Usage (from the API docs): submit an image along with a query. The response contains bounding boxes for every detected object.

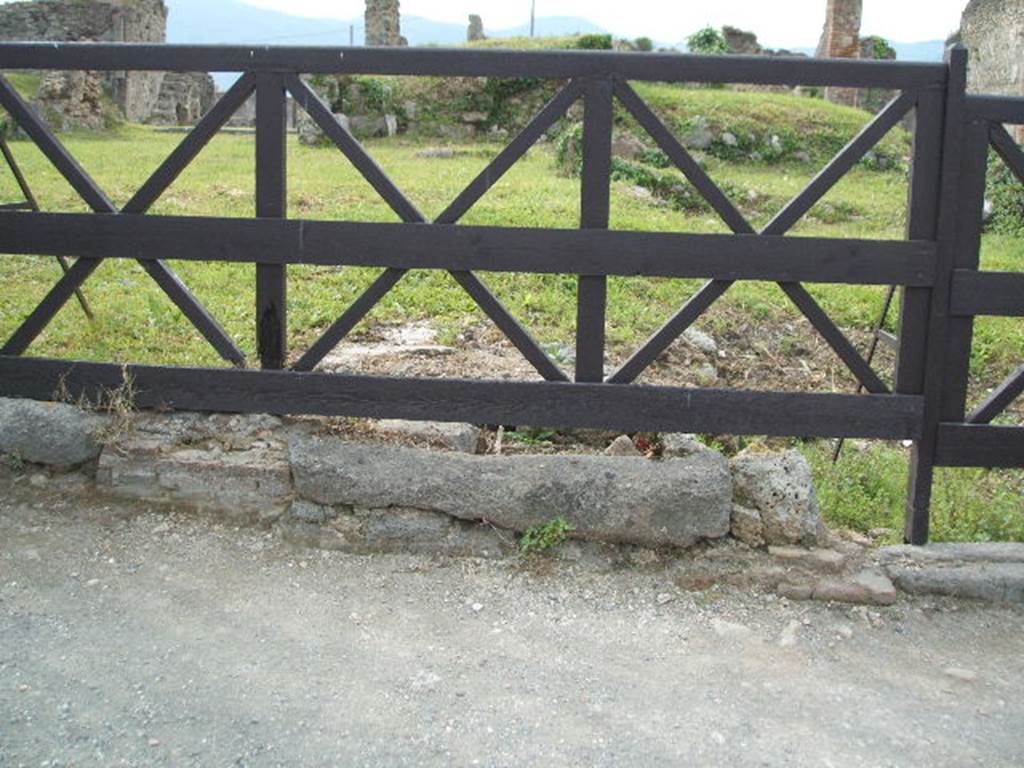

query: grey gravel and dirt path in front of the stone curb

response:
[0,480,1024,768]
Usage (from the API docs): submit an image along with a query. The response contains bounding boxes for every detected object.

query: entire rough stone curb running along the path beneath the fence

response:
[0,398,1024,605]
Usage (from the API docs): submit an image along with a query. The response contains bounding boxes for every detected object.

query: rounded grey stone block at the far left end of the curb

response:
[0,397,109,467]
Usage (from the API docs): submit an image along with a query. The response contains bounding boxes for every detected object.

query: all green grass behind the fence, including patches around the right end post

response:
[0,121,1024,539]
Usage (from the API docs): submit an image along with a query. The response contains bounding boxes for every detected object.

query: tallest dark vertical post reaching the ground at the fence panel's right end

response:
[898,46,967,545]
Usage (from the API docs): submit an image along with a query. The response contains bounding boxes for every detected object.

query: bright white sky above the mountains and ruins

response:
[239,0,967,47]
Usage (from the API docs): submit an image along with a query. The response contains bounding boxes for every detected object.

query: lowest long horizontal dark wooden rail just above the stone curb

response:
[0,356,923,439]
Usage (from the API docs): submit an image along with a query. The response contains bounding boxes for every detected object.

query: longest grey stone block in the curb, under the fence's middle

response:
[291,436,732,547]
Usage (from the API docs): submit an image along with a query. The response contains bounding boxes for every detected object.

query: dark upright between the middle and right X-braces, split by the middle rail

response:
[575,78,612,382]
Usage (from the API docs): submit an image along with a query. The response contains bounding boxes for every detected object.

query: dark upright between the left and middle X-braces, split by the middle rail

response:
[256,74,288,369]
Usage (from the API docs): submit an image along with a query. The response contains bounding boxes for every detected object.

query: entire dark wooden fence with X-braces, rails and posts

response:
[0,43,1024,543]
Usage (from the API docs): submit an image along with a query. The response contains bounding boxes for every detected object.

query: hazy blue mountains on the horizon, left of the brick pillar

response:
[167,0,605,45]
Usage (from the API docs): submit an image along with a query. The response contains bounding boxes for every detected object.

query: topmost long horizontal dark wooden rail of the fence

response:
[0,43,947,88]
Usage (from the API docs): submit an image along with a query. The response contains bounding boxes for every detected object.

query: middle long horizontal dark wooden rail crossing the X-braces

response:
[0,212,935,286]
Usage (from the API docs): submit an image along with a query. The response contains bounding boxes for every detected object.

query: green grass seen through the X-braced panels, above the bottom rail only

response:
[0,127,925,364]
